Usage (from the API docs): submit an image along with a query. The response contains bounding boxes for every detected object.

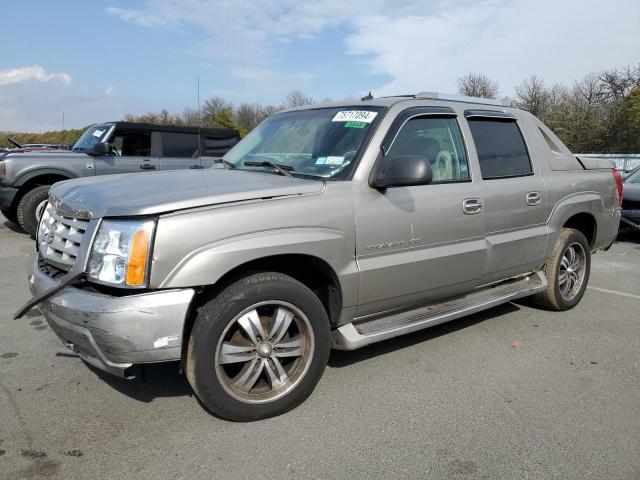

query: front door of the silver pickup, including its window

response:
[355,109,486,316]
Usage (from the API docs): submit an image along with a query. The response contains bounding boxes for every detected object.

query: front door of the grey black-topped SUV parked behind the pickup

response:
[96,129,158,175]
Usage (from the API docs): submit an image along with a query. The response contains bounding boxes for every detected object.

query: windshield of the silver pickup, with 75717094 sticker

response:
[224,107,382,178]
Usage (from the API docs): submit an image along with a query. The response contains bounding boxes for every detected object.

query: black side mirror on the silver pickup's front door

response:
[371,155,433,188]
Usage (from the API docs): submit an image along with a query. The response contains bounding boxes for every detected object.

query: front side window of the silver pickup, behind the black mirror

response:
[387,117,470,183]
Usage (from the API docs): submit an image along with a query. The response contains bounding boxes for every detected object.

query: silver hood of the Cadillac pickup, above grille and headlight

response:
[49,168,325,219]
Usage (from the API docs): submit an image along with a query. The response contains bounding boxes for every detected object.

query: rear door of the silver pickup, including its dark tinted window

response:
[465,110,547,281]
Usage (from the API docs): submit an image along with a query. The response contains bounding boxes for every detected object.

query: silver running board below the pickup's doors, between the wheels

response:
[332,272,547,350]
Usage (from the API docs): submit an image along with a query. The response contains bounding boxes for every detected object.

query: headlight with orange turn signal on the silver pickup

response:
[87,220,155,288]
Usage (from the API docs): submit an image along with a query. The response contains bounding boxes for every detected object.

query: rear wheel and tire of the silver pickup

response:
[532,228,591,311]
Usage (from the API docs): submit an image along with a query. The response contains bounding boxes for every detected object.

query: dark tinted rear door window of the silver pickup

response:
[469,118,532,180]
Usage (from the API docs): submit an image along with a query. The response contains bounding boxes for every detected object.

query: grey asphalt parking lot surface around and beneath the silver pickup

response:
[0,217,640,479]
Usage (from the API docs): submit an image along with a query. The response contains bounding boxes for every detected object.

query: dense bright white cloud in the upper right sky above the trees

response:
[347,0,640,95]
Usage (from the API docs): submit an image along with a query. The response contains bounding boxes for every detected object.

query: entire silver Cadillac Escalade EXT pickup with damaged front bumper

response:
[16,93,622,420]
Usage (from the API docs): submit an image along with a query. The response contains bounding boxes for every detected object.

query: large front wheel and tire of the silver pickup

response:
[185,272,331,421]
